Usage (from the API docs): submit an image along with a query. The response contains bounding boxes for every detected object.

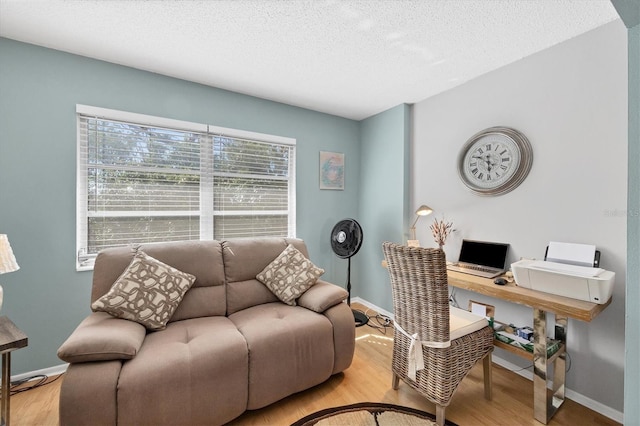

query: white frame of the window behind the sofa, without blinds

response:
[76,104,296,271]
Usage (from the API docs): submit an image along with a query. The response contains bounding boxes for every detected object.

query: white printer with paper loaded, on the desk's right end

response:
[511,242,616,304]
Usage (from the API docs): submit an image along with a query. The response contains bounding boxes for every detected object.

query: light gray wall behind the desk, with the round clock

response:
[411,21,624,412]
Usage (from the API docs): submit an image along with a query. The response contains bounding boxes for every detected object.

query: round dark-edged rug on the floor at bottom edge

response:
[291,402,457,426]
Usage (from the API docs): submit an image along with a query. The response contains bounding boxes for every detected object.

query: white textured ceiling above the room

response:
[0,0,619,120]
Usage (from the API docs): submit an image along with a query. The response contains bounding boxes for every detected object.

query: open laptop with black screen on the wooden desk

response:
[447,240,509,278]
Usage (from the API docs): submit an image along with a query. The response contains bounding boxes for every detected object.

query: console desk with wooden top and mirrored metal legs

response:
[447,271,611,424]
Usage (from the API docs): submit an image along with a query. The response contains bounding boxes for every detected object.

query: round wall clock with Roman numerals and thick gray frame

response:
[458,127,533,195]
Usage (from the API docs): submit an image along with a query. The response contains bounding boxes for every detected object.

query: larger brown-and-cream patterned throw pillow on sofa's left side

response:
[91,250,196,330]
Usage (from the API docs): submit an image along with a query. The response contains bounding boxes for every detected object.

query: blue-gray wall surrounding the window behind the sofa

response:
[0,38,360,374]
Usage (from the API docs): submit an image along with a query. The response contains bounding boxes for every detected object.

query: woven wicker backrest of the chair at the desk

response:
[382,242,449,342]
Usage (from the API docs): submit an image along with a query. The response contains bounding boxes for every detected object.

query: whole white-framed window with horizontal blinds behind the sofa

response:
[77,105,295,269]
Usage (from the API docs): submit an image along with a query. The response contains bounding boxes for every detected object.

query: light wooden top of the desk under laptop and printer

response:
[447,271,611,322]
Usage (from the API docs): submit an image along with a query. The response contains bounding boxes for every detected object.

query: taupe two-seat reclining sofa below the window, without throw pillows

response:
[58,238,355,426]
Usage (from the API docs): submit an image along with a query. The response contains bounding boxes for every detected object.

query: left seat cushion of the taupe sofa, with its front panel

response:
[117,316,249,425]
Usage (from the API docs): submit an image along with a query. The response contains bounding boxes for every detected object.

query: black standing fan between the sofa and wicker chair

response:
[331,219,369,327]
